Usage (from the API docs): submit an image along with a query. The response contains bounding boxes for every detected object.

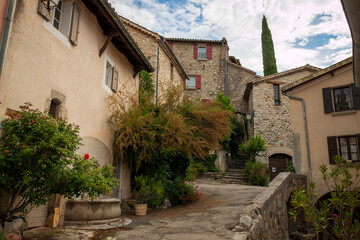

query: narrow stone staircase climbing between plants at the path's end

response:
[220,154,250,185]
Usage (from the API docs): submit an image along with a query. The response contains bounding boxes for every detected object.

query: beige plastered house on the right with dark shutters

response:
[283,57,360,198]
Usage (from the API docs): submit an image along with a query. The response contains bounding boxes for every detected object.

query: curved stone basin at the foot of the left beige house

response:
[65,198,121,225]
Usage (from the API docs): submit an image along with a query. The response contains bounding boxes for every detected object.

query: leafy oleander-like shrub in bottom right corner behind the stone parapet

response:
[289,156,360,240]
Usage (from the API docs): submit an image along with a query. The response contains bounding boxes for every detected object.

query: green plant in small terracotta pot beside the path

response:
[133,175,153,216]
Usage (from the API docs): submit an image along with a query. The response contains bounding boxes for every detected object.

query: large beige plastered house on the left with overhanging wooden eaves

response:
[0,0,153,227]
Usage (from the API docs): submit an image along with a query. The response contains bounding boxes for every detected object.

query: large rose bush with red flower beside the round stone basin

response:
[0,103,117,218]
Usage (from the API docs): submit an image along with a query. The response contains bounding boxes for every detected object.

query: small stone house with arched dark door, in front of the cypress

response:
[248,65,319,179]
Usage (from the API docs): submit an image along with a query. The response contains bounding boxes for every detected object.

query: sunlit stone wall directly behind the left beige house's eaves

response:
[123,20,185,100]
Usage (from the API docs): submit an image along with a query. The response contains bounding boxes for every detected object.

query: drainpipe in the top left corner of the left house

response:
[0,0,17,79]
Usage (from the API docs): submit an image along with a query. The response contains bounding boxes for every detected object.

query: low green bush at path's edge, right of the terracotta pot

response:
[167,178,201,206]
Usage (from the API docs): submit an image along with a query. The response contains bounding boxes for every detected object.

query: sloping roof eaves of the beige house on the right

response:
[281,57,352,92]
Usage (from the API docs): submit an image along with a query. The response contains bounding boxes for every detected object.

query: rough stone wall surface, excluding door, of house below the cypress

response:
[252,71,311,164]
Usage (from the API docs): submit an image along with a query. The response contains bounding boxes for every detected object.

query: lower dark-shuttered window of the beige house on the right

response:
[327,134,360,164]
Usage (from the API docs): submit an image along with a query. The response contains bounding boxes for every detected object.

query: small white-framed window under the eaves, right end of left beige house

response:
[103,54,119,93]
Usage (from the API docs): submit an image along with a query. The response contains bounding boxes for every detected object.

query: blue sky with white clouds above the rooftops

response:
[108,0,352,76]
